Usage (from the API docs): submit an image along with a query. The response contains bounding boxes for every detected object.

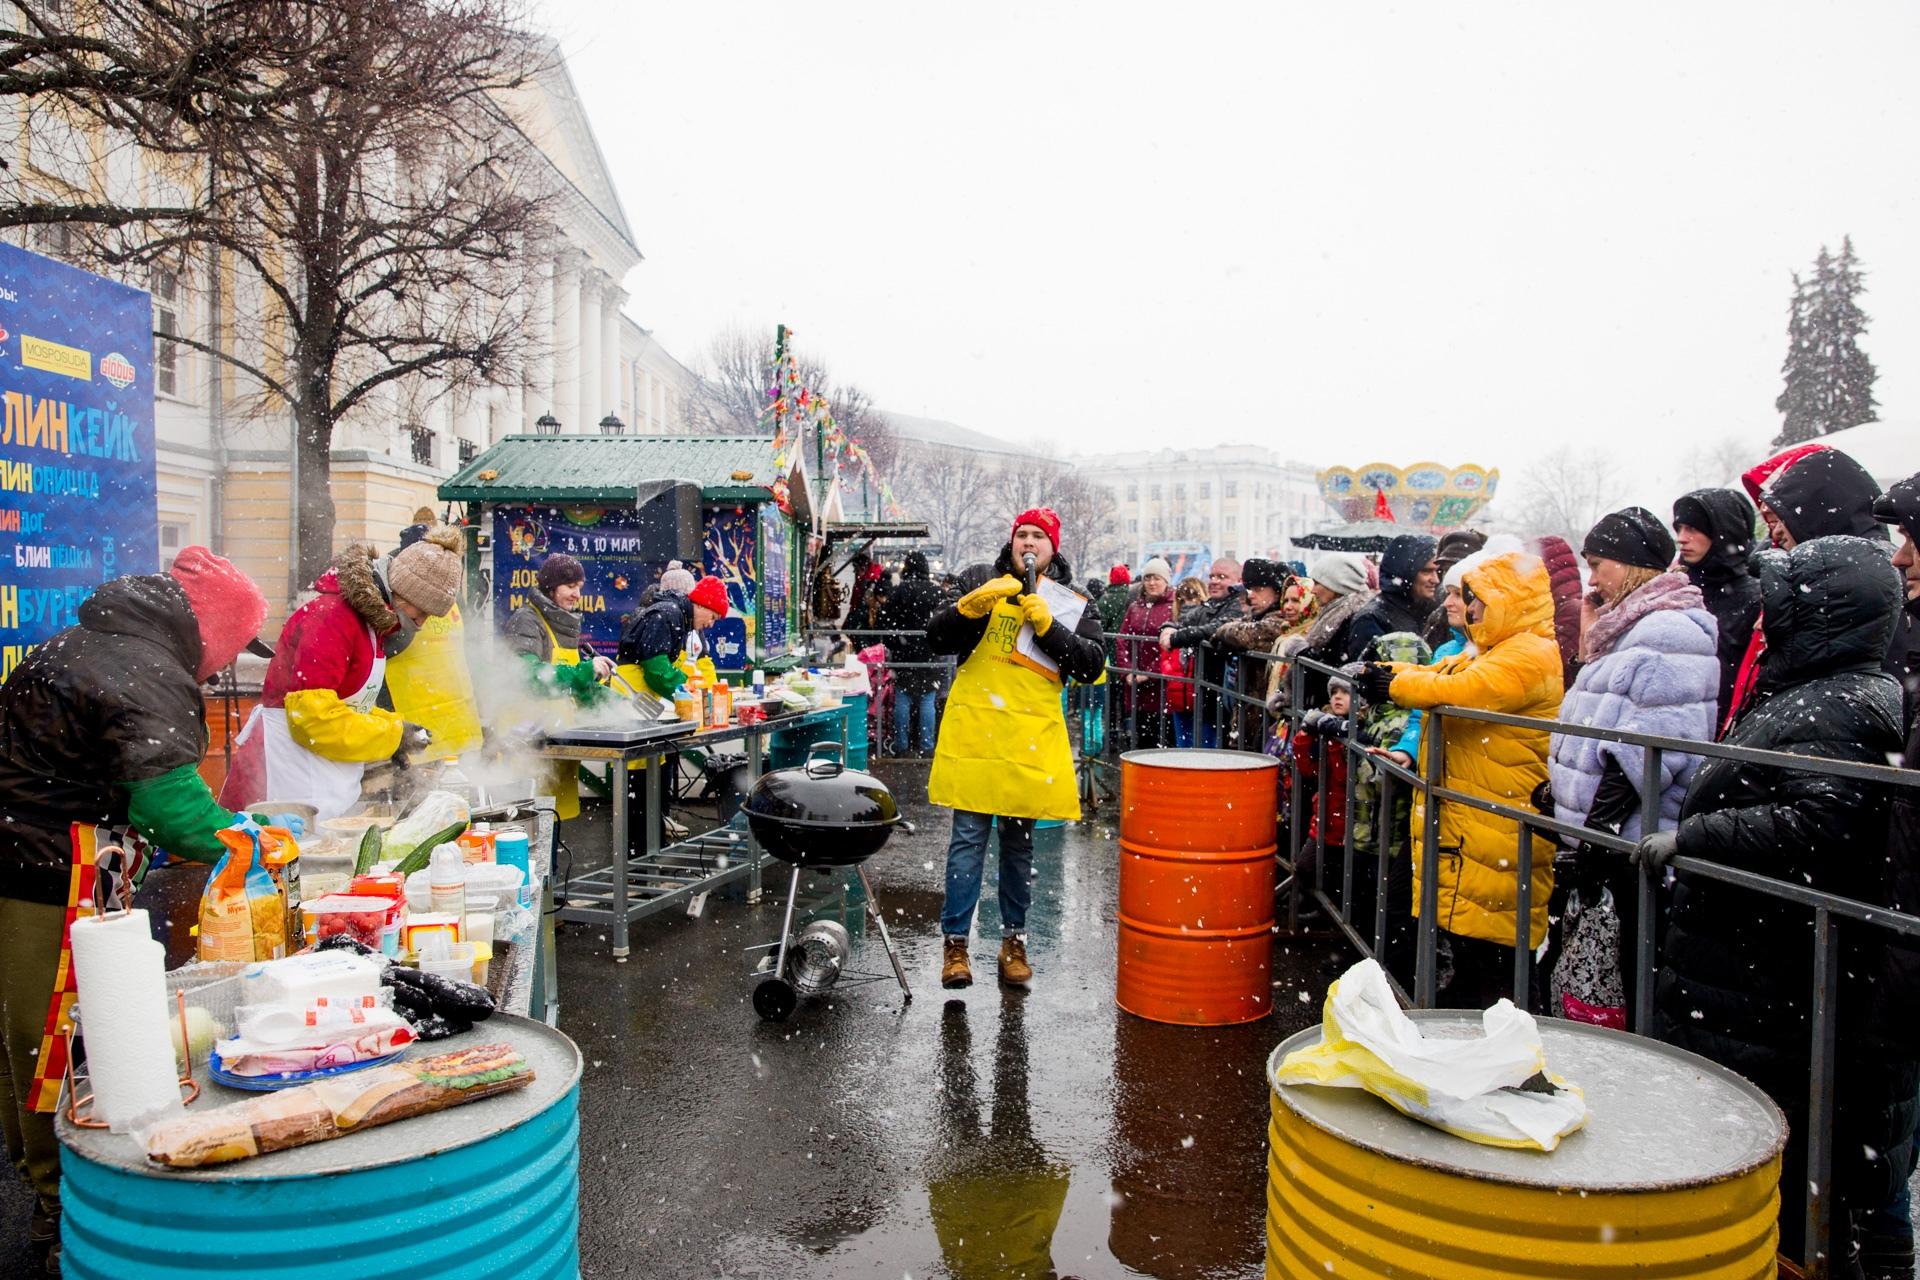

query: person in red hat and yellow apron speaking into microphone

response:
[927,507,1106,986]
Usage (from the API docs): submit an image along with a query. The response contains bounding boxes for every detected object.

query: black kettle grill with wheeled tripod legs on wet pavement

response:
[741,743,914,1023]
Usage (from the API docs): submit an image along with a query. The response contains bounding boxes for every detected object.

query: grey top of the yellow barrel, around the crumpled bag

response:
[1267,1009,1788,1192]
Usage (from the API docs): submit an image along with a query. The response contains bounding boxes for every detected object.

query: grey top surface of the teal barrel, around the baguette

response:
[58,1013,580,1182]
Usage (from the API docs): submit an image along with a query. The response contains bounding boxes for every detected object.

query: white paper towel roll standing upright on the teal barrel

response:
[73,912,180,1134]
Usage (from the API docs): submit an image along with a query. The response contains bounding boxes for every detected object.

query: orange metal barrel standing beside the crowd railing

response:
[1116,750,1281,1027]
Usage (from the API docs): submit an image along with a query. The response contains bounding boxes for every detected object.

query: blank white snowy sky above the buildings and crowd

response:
[536,0,1920,495]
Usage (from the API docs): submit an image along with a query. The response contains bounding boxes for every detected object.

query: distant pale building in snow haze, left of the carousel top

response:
[1073,445,1331,564]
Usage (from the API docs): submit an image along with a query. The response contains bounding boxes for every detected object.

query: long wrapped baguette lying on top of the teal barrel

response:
[146,1044,534,1169]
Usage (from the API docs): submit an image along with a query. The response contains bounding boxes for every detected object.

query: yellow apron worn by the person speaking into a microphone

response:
[927,601,1079,821]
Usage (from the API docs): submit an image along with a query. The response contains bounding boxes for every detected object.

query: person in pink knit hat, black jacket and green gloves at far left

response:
[0,547,267,1255]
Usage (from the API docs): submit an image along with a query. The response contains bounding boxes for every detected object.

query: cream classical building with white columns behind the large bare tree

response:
[0,46,697,621]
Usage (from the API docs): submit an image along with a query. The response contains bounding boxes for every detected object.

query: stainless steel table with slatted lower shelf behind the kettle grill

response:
[538,706,847,960]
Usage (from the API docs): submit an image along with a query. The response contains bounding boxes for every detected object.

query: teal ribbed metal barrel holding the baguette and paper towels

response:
[60,1015,580,1280]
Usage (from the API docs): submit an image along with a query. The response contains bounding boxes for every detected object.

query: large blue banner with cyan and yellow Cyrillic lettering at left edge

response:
[0,244,159,677]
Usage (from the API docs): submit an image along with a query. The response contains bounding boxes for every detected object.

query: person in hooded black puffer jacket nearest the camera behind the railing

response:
[1638,535,1920,1274]
